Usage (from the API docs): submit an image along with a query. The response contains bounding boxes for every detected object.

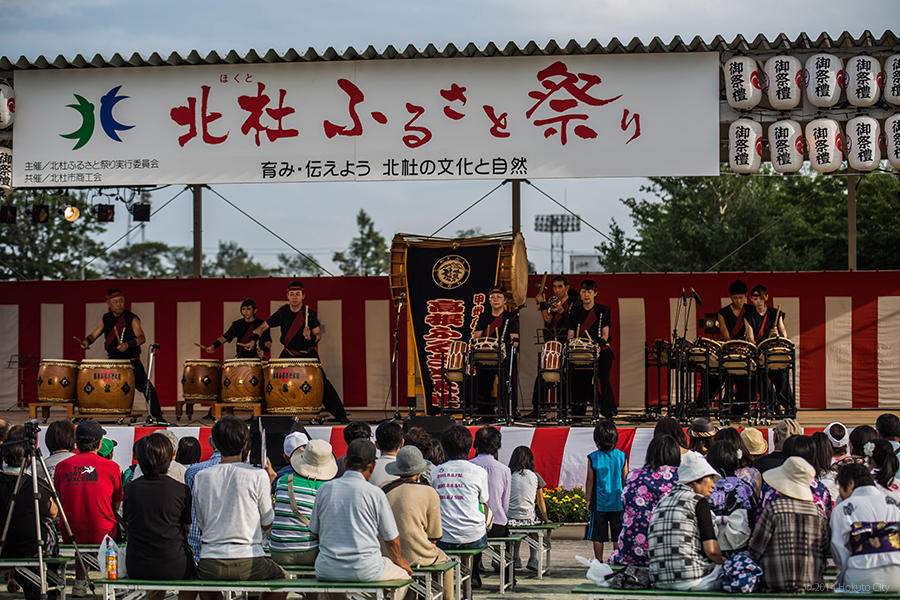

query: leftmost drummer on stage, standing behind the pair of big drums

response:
[81,288,165,425]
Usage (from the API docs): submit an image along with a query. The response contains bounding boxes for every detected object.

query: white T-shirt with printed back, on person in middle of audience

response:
[431,460,489,544]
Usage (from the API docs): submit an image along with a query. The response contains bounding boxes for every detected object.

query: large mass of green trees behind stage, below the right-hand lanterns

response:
[597,173,900,271]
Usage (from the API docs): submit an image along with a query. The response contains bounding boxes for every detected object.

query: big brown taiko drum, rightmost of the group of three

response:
[265,358,325,414]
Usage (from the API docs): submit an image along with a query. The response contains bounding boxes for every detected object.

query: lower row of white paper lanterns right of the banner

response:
[728,114,900,174]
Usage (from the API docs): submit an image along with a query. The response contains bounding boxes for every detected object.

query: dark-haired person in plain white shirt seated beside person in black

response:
[193,416,287,599]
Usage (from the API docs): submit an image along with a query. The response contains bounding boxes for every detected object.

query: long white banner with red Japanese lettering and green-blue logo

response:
[13,53,719,187]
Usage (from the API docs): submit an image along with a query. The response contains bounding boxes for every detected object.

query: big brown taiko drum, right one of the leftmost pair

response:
[78,359,134,415]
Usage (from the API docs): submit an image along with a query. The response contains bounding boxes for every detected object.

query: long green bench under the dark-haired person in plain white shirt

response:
[95,579,413,600]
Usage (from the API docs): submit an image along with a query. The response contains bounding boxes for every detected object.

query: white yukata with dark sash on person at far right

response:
[831,485,900,581]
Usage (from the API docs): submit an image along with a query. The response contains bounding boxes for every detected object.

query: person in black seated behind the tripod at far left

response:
[0,425,59,600]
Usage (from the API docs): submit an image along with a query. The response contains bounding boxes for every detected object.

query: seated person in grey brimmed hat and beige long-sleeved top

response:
[381,446,454,600]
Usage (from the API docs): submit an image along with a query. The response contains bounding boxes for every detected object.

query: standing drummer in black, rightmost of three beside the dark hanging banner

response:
[568,279,618,419]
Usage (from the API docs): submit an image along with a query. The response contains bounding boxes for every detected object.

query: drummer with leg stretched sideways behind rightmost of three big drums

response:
[251,281,349,423]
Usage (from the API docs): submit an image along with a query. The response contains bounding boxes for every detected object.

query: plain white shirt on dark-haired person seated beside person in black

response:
[193,463,275,558]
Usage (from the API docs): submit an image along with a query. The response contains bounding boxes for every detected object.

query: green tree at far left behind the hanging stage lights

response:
[0,190,106,279]
